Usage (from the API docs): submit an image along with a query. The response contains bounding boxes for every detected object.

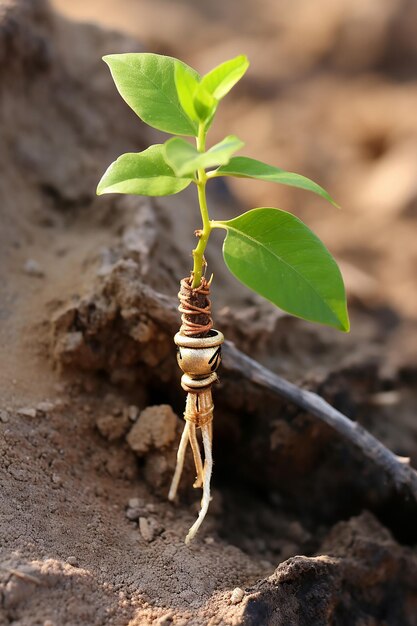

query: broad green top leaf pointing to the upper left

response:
[103,53,200,136]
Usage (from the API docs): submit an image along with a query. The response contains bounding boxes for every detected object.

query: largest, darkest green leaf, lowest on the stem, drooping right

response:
[212,208,349,332]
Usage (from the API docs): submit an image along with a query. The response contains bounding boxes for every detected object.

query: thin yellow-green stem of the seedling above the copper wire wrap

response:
[191,124,211,289]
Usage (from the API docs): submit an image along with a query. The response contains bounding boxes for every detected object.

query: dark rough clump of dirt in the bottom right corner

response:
[244,513,417,626]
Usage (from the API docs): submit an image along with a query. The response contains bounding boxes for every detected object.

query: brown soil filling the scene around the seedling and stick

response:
[0,0,417,626]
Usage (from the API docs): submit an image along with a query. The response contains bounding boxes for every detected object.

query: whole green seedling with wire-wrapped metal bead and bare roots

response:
[97,53,349,542]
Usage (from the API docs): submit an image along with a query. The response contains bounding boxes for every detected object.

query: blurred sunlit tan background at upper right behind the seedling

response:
[52,0,417,326]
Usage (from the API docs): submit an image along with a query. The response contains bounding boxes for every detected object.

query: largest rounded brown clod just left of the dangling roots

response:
[127,404,178,457]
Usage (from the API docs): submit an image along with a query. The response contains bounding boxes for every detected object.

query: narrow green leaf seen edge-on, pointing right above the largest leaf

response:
[212,157,339,208]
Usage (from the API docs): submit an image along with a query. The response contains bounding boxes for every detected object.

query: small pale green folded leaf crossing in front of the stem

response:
[164,135,244,176]
